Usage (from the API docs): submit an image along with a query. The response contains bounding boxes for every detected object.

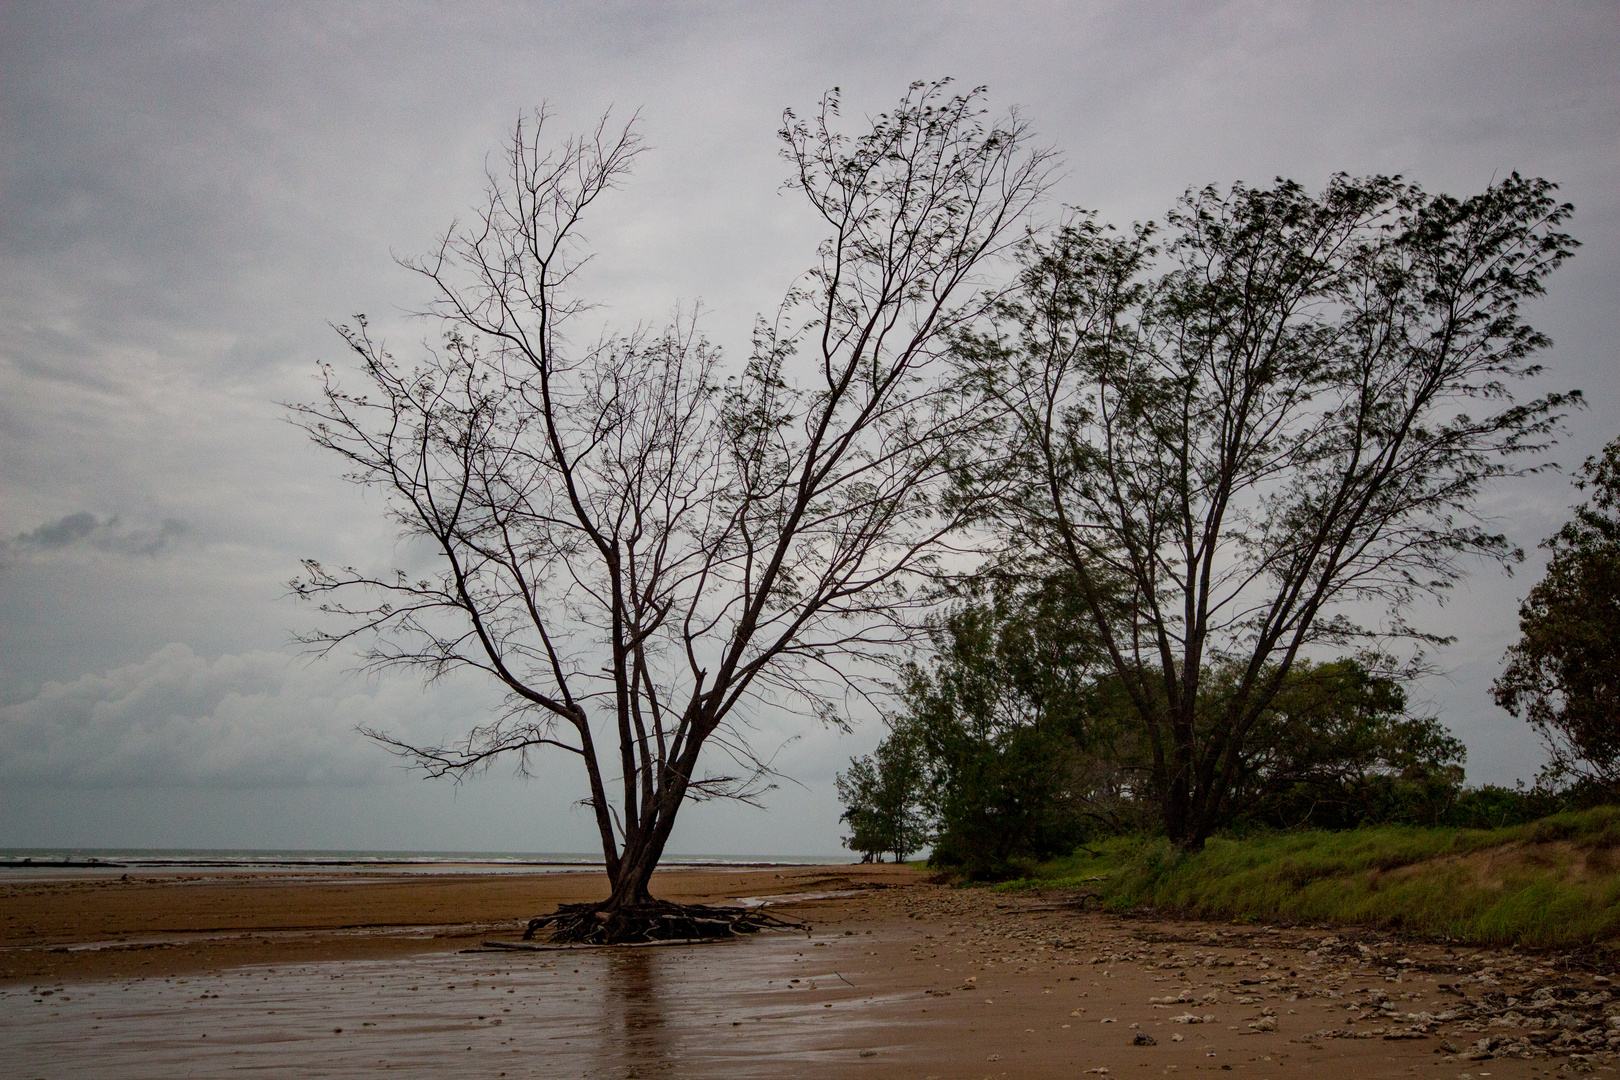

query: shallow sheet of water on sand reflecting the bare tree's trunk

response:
[0,934,926,1080]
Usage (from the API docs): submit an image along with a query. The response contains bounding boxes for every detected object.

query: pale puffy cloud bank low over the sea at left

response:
[0,643,476,787]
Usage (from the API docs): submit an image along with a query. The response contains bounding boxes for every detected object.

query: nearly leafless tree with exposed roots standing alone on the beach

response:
[293,83,1050,939]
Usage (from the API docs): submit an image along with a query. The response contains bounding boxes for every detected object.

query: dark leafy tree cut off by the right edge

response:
[1494,439,1620,792]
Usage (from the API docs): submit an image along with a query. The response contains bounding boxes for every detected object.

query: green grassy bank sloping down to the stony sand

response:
[1009,806,1620,947]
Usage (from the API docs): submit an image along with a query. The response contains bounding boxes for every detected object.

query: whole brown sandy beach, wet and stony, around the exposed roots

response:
[0,866,1620,1080]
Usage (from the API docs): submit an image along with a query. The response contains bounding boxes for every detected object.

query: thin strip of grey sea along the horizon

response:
[0,847,855,876]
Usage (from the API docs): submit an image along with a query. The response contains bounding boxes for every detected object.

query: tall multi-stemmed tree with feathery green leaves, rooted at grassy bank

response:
[962,175,1580,848]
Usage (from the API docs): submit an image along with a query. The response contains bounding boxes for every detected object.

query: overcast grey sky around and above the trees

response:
[0,0,1620,853]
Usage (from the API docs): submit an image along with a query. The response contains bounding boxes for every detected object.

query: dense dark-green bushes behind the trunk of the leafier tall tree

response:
[839,572,1483,879]
